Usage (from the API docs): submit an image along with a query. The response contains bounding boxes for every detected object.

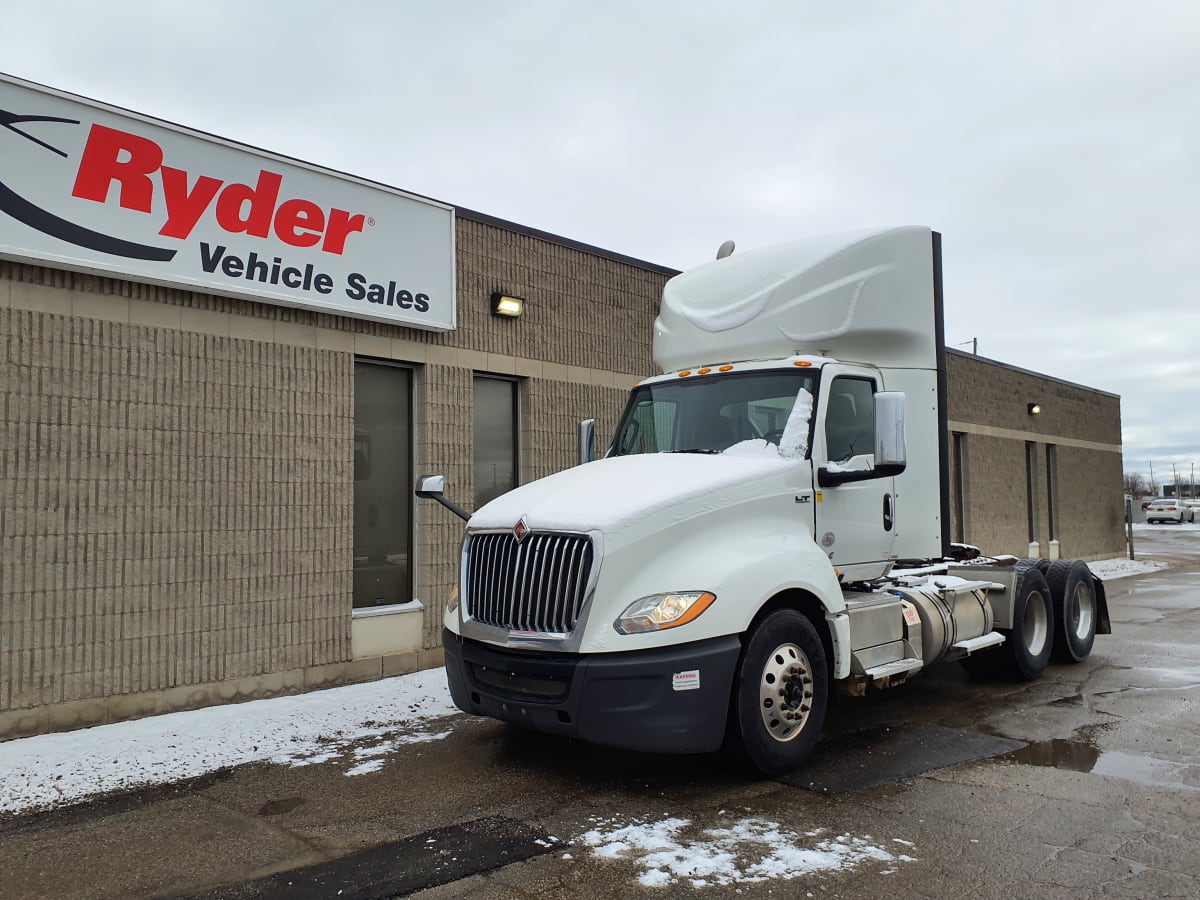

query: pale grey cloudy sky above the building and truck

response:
[0,0,1200,480]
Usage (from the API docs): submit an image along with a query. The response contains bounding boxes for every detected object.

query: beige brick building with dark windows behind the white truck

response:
[0,81,1123,739]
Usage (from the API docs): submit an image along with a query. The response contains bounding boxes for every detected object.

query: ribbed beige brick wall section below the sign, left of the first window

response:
[0,308,353,709]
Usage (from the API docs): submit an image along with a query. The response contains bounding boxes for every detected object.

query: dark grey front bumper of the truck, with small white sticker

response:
[442,630,742,754]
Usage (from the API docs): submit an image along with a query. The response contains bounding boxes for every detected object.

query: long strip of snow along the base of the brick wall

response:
[0,668,458,815]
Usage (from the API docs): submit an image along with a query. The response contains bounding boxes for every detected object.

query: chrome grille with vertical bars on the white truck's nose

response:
[463,533,592,634]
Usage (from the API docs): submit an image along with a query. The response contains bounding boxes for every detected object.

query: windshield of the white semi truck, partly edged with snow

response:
[608,368,817,456]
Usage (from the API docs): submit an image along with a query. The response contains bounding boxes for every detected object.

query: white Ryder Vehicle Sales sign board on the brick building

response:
[0,74,456,331]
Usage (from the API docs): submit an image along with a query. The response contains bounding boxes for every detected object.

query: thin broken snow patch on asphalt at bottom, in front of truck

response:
[578,817,914,888]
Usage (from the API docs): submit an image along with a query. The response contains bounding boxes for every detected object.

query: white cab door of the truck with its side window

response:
[812,373,895,581]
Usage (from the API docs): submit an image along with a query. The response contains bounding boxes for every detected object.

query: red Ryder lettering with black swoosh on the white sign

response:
[0,109,364,262]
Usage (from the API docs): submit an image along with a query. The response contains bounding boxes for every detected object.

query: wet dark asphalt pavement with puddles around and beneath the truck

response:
[0,526,1200,900]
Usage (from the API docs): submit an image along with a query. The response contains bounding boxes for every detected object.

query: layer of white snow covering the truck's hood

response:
[468,451,796,533]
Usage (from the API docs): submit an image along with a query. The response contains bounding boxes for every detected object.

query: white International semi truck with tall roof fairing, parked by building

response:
[418,227,1110,774]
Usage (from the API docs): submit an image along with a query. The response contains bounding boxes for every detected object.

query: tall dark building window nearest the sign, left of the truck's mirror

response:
[354,361,413,608]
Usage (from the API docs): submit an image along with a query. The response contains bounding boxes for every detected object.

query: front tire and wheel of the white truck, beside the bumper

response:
[728,610,829,775]
